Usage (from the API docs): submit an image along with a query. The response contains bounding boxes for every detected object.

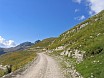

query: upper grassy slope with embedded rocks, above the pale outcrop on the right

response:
[49,11,104,55]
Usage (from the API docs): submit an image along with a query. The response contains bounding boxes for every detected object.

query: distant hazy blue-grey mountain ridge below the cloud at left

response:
[0,42,34,54]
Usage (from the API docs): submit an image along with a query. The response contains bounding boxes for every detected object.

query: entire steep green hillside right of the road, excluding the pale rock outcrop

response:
[49,10,104,78]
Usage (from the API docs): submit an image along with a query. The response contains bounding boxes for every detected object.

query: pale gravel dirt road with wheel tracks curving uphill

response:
[13,53,64,78]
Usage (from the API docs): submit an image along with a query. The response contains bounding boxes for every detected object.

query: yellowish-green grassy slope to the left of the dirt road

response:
[0,51,36,76]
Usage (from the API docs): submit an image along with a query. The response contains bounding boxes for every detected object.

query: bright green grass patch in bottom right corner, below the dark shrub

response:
[76,54,104,78]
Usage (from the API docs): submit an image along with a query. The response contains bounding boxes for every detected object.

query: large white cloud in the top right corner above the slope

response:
[87,0,104,15]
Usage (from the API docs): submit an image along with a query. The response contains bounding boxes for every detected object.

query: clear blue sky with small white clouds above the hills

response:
[0,0,104,47]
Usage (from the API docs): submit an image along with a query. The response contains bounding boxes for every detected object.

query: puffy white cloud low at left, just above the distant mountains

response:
[0,36,16,48]
